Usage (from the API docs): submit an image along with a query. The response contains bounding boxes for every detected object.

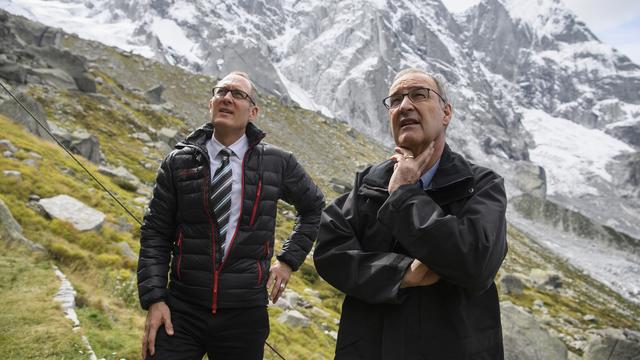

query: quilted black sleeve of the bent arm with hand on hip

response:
[276,153,324,271]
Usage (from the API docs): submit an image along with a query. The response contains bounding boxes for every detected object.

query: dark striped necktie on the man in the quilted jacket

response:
[211,148,233,260]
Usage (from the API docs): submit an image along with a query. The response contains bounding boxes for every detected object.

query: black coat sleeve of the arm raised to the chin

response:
[378,170,507,292]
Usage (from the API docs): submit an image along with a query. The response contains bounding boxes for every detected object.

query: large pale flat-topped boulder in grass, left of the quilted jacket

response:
[38,195,105,231]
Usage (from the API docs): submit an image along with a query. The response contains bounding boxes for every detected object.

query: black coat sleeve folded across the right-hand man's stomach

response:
[313,174,413,303]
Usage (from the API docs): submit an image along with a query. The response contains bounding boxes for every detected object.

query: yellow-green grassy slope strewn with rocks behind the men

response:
[0,31,640,359]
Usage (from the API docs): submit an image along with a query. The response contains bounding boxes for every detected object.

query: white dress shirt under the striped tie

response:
[206,134,249,257]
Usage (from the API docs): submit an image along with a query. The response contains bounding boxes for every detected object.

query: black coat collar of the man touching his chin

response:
[363,144,473,191]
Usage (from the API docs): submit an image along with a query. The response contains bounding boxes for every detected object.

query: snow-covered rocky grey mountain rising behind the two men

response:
[0,0,640,295]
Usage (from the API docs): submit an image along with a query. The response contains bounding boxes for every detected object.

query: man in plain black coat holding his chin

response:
[314,69,507,360]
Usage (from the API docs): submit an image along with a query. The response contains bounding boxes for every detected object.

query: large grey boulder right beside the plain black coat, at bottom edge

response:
[500,301,568,360]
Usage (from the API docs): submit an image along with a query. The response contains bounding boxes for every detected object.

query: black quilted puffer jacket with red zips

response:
[138,123,324,313]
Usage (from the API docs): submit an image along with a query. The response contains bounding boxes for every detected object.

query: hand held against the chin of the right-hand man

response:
[388,141,435,194]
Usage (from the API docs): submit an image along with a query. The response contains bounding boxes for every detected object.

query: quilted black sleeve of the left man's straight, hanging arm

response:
[138,154,176,310]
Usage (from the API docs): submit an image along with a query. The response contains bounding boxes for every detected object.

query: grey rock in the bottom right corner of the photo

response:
[583,329,640,360]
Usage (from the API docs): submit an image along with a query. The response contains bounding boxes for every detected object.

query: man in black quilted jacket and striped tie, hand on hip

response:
[138,72,324,360]
